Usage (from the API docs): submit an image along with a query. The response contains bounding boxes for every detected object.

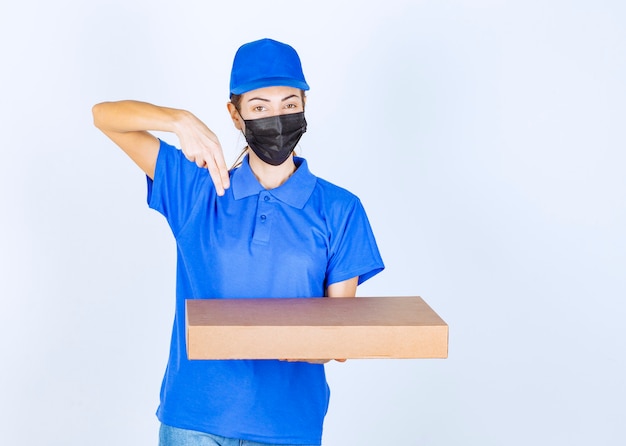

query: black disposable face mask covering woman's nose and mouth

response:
[244,112,306,166]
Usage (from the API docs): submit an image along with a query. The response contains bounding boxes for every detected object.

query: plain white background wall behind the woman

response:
[0,0,626,446]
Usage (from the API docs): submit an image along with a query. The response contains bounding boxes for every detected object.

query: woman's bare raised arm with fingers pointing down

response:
[92,101,229,195]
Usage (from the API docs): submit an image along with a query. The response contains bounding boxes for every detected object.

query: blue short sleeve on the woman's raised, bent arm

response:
[147,141,214,235]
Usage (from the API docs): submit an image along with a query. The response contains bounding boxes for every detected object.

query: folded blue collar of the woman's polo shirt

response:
[231,156,317,209]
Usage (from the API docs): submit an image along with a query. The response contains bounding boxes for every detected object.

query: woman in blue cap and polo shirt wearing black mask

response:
[93,39,384,446]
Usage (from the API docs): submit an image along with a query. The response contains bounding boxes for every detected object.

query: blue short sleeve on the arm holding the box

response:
[326,197,385,285]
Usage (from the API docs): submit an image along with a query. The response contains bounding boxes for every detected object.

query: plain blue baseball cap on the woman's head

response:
[230,39,309,94]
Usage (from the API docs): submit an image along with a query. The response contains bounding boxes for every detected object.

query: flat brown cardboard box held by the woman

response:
[186,297,448,359]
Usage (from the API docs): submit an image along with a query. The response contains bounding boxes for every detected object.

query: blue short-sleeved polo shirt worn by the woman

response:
[148,141,384,444]
